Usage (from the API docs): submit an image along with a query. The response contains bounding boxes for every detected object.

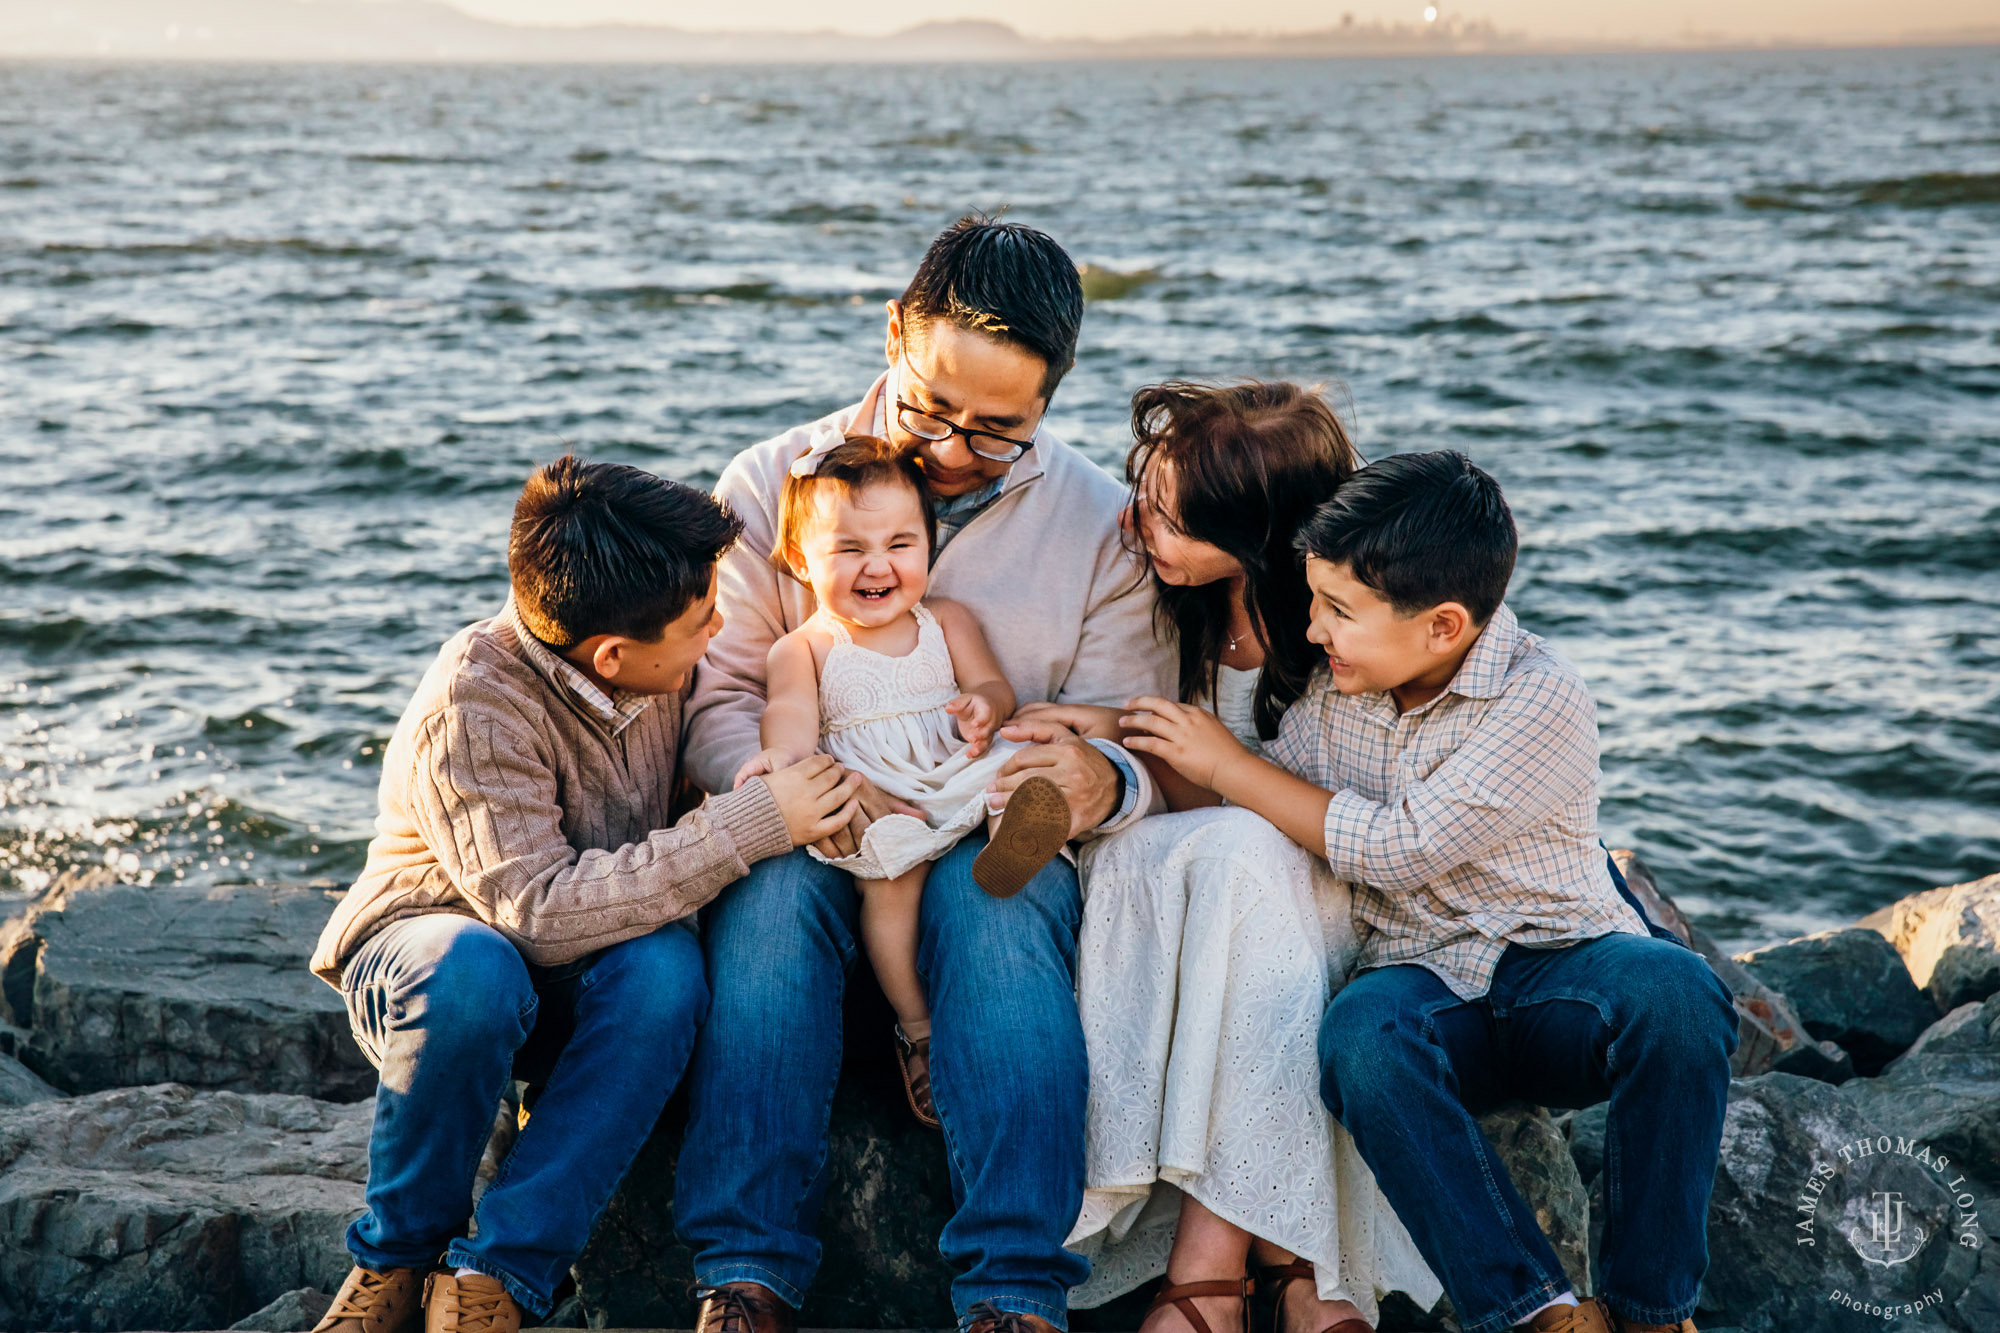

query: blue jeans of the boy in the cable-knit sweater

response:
[340,913,708,1317]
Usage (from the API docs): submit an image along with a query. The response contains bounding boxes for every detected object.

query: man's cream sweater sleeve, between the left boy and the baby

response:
[680,452,784,793]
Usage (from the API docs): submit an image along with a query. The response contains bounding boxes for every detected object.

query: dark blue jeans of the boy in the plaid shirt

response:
[1320,935,1736,1333]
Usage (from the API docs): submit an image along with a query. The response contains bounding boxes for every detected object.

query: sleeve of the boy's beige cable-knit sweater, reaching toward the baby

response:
[410,709,792,967]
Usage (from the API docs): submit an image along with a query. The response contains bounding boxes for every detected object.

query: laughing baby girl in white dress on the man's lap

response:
[736,436,1070,1127]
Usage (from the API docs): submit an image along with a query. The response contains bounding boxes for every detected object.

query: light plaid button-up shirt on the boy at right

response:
[1266,606,1646,1001]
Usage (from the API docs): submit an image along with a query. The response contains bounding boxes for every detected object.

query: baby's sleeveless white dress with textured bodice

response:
[808,602,1022,879]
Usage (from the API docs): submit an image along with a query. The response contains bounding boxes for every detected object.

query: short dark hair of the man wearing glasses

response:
[902,214,1084,398]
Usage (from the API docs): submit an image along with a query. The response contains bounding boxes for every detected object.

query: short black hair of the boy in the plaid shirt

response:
[1296,452,1518,624]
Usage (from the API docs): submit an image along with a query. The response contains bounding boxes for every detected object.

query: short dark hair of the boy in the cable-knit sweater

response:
[506,454,744,648]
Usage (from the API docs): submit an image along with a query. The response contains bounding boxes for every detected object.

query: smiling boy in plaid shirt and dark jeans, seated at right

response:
[1124,452,1736,1333]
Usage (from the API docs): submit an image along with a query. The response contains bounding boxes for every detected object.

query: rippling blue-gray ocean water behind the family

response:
[0,50,2000,945]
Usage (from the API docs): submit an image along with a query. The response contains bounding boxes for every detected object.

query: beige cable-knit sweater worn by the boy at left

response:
[312,608,792,987]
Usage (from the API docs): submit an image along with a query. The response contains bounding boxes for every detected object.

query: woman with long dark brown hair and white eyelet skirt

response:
[1022,382,1440,1333]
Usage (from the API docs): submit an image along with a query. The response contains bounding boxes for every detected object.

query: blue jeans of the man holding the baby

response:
[674,831,1090,1329]
